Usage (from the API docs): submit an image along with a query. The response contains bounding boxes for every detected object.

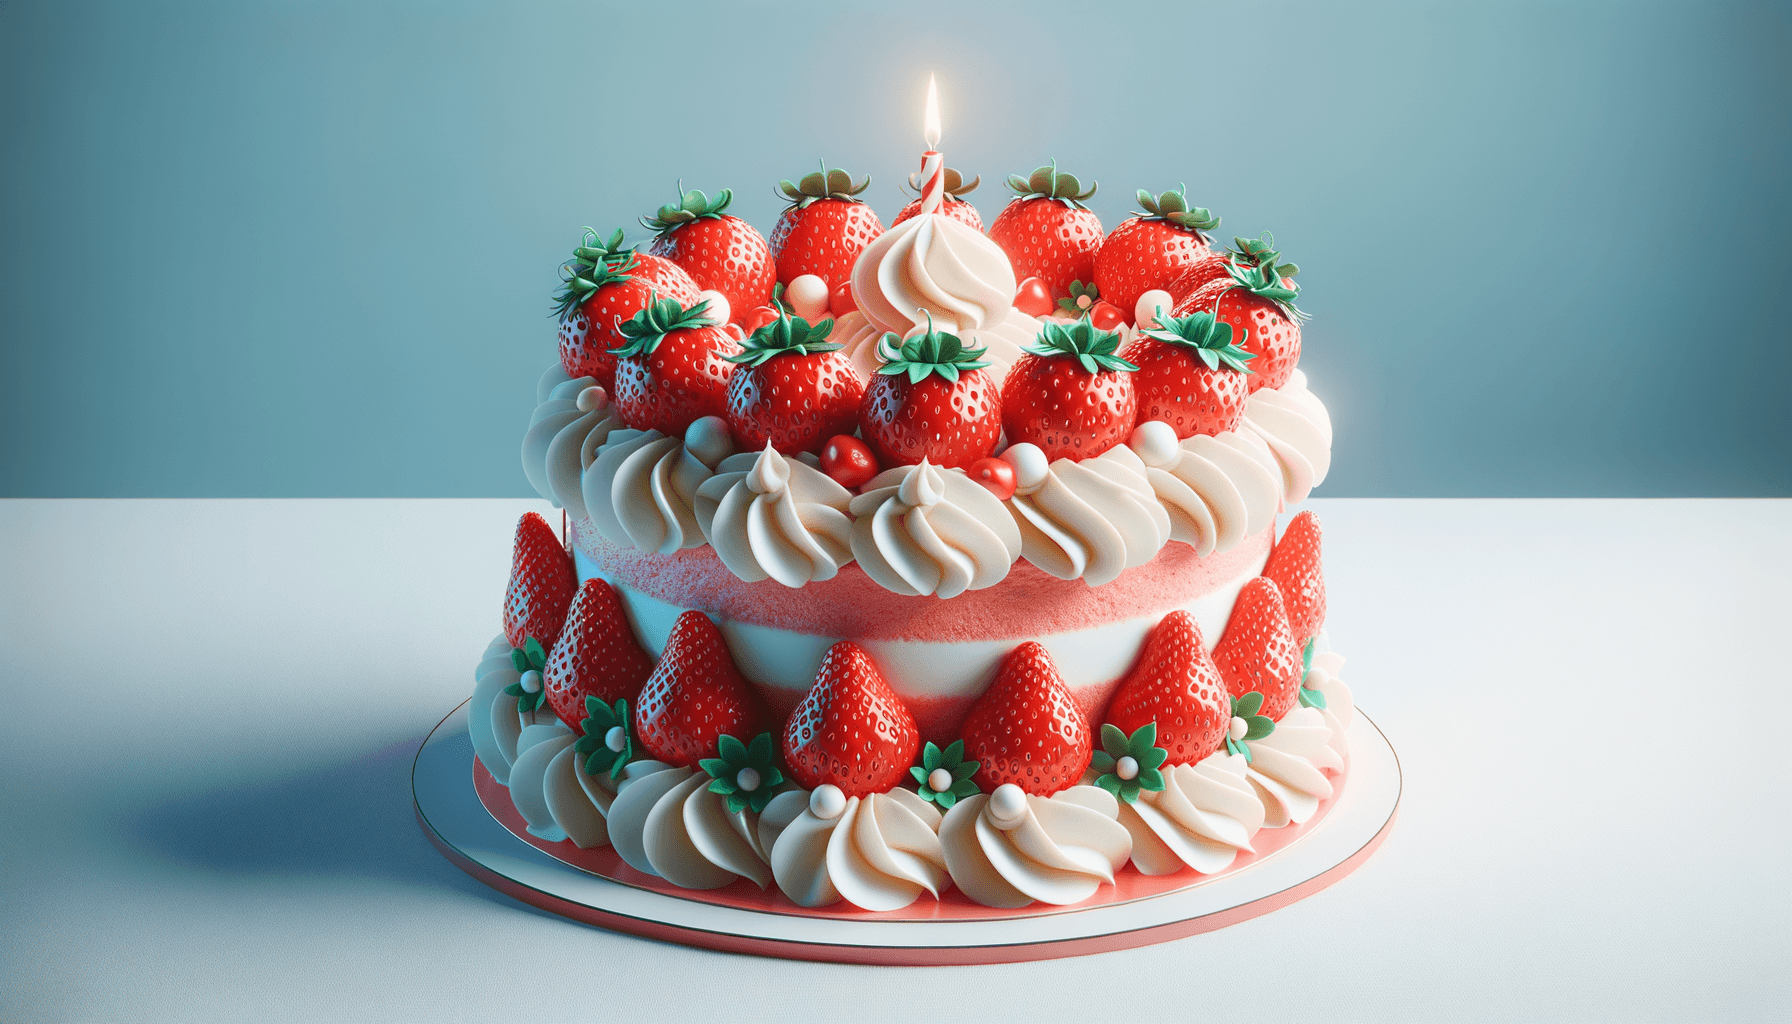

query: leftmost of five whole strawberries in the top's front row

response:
[615,299,740,438]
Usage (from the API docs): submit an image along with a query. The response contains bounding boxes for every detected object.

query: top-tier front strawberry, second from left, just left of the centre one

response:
[728,314,866,456]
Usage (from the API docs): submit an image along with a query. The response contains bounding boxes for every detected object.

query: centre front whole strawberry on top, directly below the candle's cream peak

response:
[858,316,1002,468]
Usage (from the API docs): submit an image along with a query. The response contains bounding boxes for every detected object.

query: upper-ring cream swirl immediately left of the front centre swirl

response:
[695,445,853,586]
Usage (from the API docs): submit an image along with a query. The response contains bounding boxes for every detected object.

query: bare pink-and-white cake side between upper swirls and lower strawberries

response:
[573,520,1274,742]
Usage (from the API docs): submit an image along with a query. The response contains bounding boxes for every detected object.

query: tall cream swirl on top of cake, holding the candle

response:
[853,213,1016,334]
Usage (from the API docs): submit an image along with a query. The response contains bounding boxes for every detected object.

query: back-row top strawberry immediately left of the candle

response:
[772,169,883,292]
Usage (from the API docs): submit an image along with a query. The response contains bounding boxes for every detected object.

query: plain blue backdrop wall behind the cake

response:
[0,0,1792,497]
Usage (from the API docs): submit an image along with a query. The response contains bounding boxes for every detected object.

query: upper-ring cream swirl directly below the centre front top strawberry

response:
[849,459,1021,597]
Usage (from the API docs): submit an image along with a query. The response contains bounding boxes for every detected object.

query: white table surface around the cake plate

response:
[0,500,1792,1024]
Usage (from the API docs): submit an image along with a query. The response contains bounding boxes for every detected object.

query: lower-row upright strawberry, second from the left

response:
[541,576,654,735]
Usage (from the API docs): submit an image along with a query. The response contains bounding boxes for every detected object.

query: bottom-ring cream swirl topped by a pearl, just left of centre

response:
[765,784,948,911]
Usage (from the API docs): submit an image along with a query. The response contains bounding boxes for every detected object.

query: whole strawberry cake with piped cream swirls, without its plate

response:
[468,152,1353,916]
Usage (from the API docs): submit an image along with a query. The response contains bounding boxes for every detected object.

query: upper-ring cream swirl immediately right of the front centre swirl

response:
[1002,443,1170,586]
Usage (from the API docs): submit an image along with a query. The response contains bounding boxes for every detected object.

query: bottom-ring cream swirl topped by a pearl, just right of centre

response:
[939,785,1133,907]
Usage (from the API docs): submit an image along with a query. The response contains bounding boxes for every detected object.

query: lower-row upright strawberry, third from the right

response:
[1107,612,1233,764]
